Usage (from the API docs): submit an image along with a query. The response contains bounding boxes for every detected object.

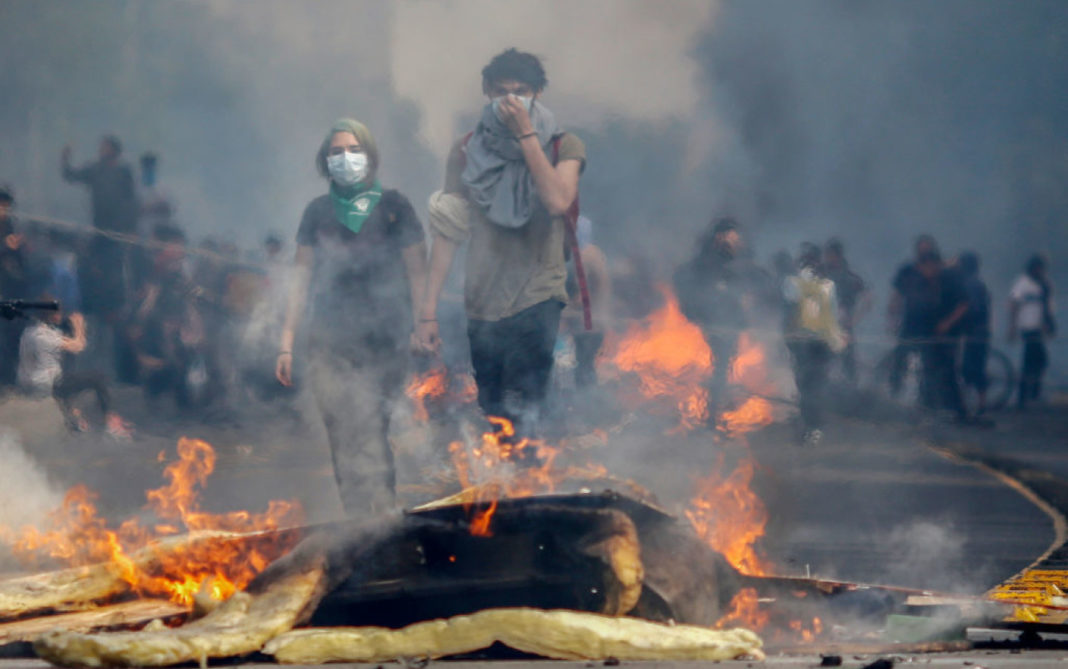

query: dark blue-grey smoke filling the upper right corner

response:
[695,0,1068,301]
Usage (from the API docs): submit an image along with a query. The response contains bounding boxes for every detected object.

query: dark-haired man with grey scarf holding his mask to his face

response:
[415,49,586,437]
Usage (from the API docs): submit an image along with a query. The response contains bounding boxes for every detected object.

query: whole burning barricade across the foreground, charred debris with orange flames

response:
[0,282,1042,666]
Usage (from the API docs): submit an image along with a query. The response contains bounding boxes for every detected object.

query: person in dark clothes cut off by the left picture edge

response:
[0,185,29,388]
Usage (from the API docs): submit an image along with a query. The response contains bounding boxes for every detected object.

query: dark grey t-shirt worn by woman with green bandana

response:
[297,190,423,361]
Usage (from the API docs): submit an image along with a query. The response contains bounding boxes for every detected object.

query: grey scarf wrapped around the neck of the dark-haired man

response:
[460,100,559,228]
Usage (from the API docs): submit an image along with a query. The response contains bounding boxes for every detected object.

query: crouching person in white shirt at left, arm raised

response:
[18,295,130,439]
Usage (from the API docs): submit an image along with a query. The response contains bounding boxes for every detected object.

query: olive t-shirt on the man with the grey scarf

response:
[444,133,586,321]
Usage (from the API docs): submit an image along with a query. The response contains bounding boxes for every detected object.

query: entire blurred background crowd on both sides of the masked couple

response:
[0,136,1056,442]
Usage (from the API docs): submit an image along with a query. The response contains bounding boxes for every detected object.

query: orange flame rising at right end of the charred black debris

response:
[686,455,770,576]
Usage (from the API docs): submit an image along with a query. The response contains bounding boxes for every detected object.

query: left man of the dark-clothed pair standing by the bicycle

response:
[886,234,941,396]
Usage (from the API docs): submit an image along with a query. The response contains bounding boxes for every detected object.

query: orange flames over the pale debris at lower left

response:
[0,438,303,605]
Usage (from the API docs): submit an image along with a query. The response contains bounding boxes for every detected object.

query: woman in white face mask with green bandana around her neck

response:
[274,119,426,515]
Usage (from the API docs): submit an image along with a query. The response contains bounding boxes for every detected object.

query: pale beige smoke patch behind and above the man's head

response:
[390,0,718,155]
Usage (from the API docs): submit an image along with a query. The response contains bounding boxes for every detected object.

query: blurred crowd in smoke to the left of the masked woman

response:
[0,136,286,435]
